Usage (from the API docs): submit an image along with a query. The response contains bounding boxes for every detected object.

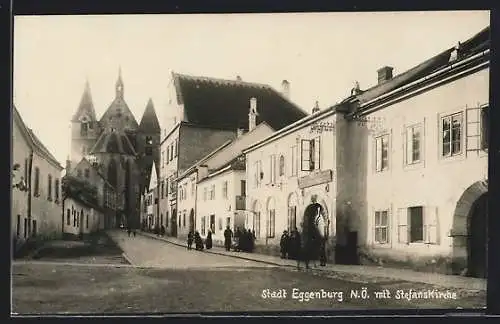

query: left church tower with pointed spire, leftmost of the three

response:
[69,80,100,165]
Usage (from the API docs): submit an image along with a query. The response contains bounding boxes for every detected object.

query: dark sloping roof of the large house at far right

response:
[354,26,490,104]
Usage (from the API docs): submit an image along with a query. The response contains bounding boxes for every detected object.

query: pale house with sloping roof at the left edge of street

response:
[11,106,63,251]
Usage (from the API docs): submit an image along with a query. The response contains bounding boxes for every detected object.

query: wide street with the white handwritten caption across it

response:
[13,231,485,313]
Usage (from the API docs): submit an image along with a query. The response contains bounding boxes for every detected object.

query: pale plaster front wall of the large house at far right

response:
[356,69,489,268]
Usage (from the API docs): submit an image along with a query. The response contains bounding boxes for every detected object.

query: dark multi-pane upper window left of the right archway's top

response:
[441,112,463,157]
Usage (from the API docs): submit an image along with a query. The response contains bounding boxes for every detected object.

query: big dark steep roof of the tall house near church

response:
[173,73,307,129]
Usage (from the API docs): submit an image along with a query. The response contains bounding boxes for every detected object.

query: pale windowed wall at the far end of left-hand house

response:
[31,152,62,238]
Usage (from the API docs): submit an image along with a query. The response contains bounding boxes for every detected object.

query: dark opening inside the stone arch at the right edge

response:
[467,193,488,278]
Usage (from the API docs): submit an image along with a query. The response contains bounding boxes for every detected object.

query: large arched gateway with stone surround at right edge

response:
[451,181,488,278]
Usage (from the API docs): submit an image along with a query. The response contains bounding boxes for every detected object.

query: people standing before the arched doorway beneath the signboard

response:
[280,227,326,268]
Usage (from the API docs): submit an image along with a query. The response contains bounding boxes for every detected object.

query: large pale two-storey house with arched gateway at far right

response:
[336,27,491,277]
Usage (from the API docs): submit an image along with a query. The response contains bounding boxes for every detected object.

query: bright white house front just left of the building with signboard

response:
[196,170,245,243]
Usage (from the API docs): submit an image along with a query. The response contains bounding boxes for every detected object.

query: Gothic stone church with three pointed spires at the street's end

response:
[67,69,160,228]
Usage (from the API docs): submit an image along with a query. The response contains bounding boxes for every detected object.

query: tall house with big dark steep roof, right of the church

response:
[160,73,307,236]
